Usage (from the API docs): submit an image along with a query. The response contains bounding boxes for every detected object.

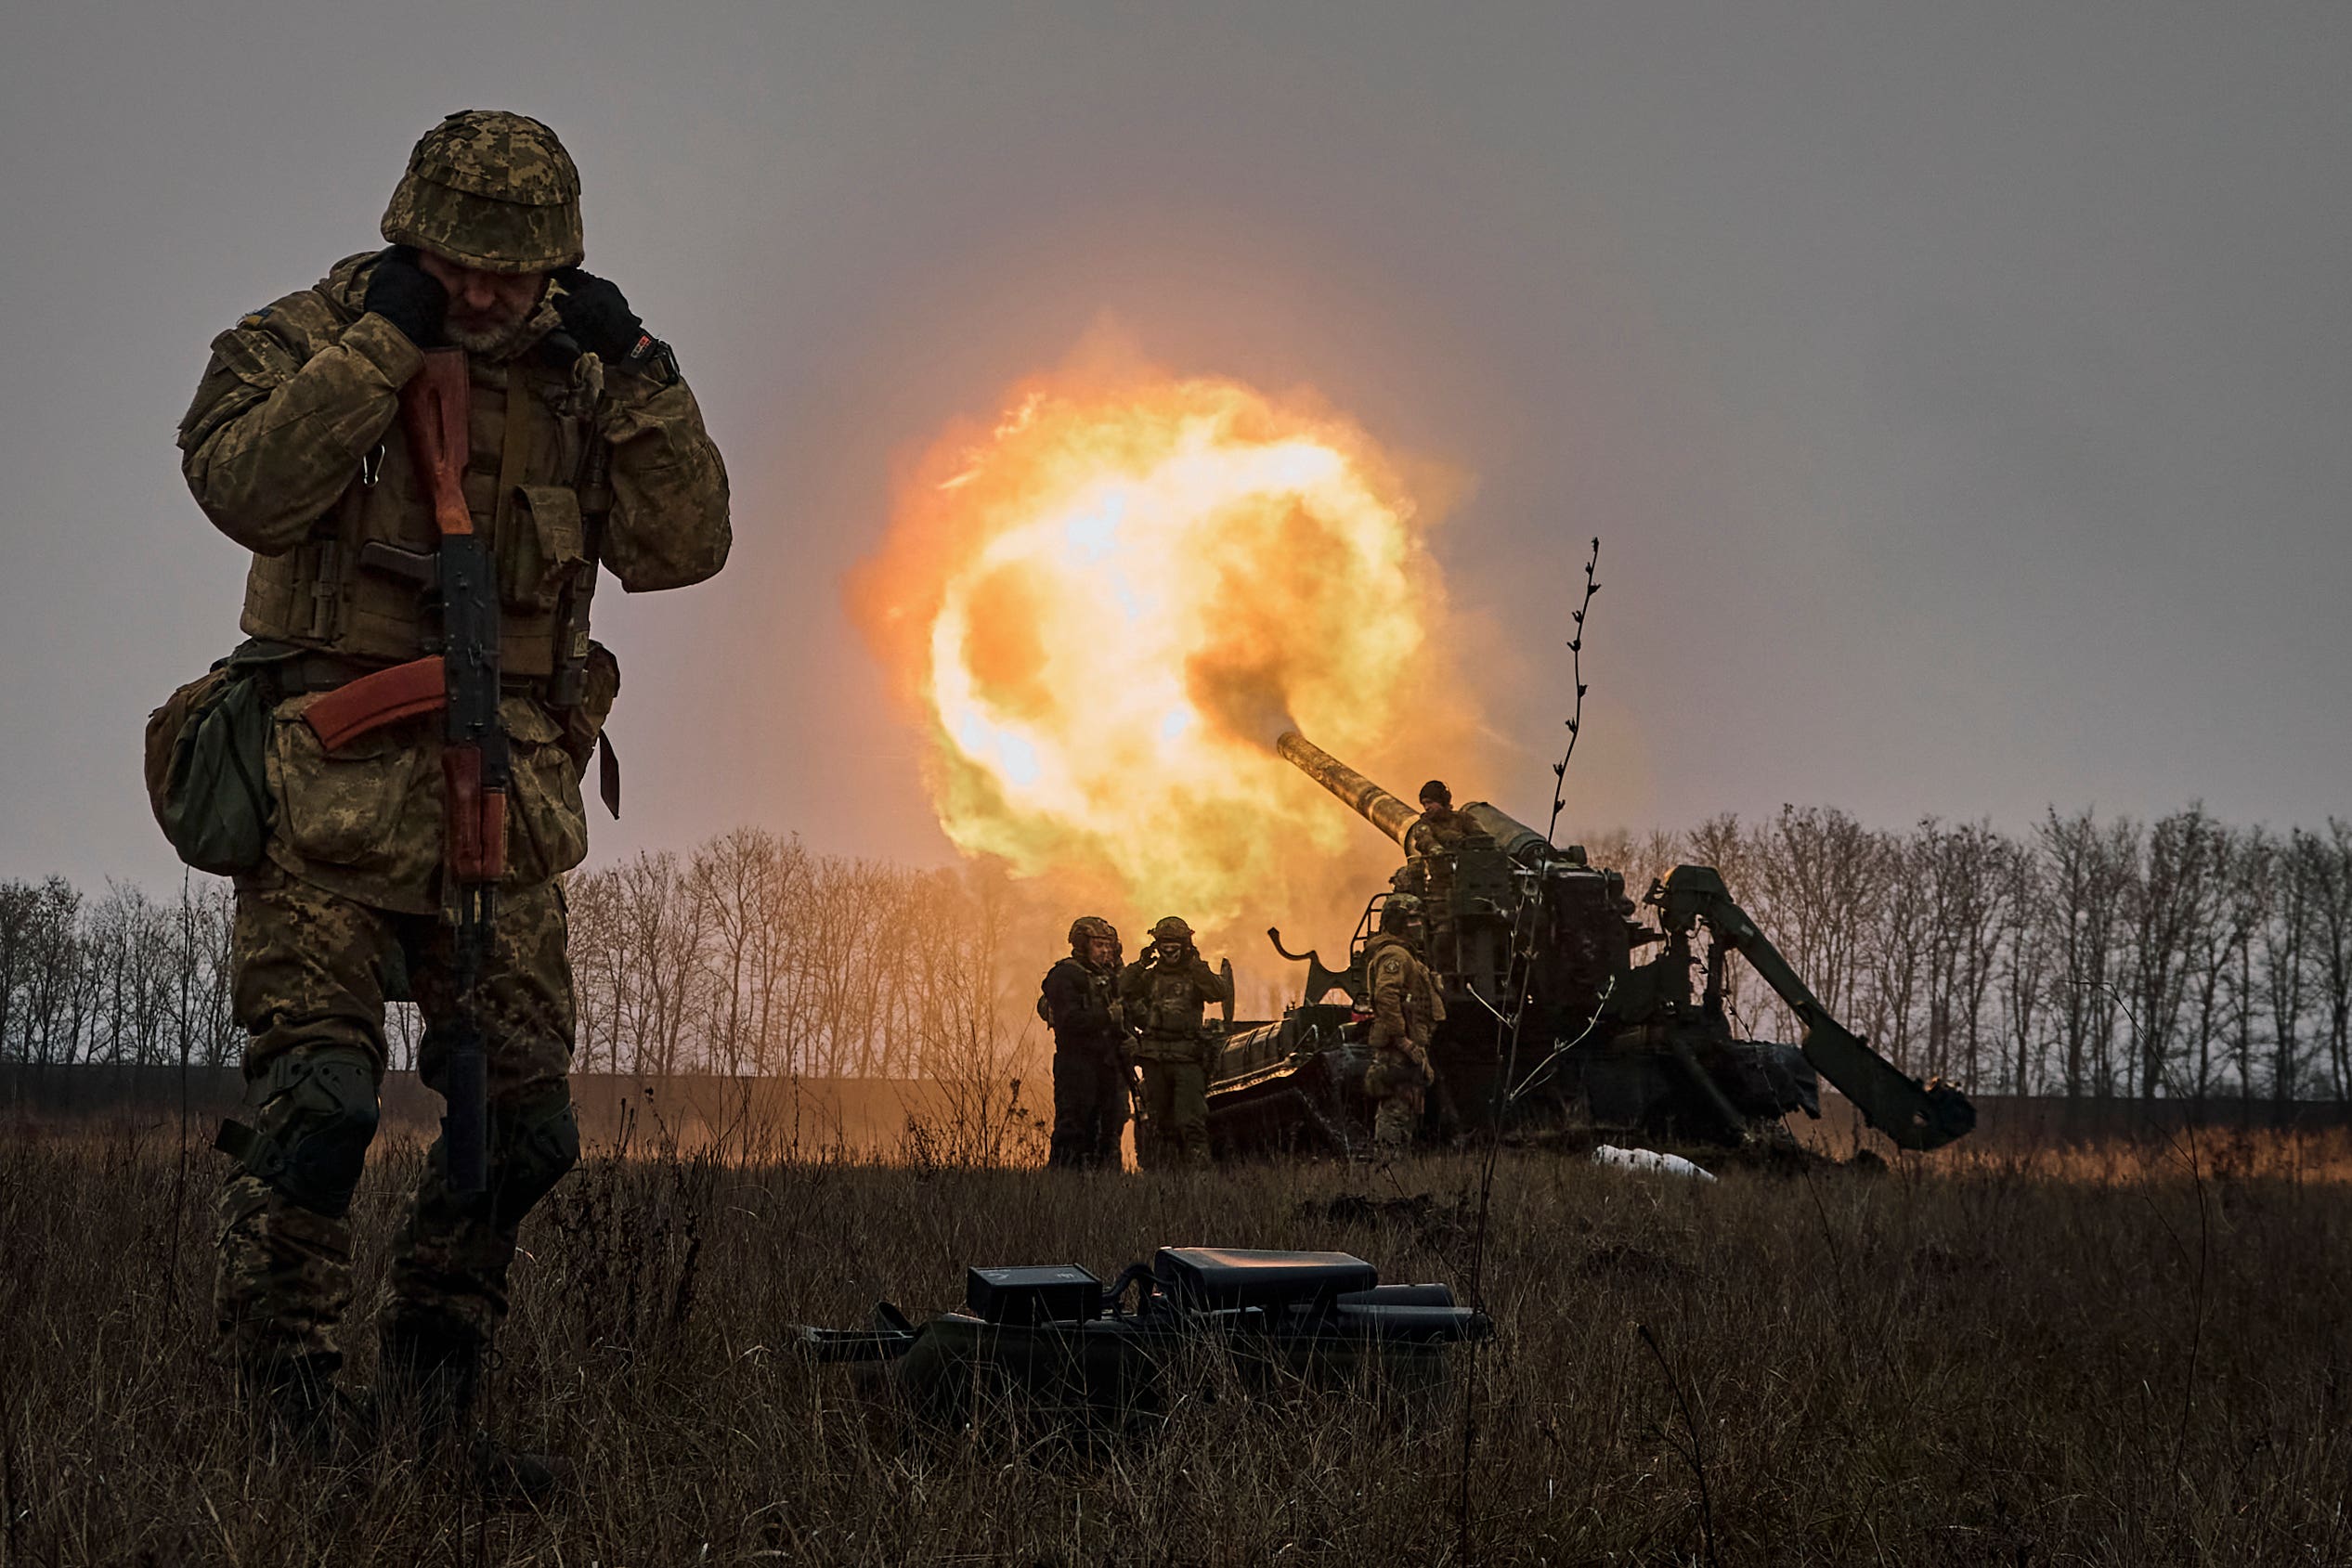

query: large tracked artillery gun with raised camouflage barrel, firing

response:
[1209,732,1976,1152]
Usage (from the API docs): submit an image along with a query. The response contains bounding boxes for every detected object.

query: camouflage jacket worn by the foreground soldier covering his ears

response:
[179,253,732,914]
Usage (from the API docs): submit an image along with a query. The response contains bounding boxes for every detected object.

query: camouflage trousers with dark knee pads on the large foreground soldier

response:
[214,867,578,1378]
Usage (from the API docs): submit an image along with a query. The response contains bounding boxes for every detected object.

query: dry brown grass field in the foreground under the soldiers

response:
[0,1109,2352,1568]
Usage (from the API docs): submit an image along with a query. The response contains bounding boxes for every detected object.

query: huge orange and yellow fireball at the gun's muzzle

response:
[851,371,1463,927]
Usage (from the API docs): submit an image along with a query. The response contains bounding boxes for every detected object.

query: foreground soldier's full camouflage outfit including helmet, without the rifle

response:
[179,110,729,1457]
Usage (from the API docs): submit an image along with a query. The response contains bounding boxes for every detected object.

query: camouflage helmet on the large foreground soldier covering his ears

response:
[383,108,581,273]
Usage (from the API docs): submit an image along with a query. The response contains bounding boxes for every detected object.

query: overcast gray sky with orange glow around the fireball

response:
[0,0,2352,882]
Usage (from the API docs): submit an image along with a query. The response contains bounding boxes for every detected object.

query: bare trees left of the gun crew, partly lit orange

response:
[0,827,1040,1077]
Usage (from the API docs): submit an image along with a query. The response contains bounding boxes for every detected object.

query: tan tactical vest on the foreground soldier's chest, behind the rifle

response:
[240,341,588,677]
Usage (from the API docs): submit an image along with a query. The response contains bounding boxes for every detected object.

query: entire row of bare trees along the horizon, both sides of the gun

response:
[0,807,2352,1100]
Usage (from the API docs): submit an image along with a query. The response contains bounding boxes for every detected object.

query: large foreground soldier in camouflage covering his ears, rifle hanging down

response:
[149,110,729,1485]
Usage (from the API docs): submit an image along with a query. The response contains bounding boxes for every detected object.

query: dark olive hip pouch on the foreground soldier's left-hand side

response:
[146,649,278,877]
